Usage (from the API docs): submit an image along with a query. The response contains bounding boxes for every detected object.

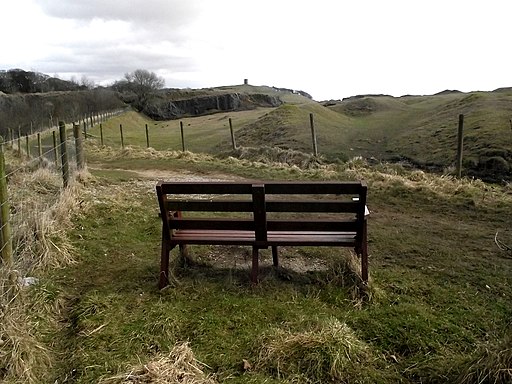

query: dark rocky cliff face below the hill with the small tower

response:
[142,93,282,120]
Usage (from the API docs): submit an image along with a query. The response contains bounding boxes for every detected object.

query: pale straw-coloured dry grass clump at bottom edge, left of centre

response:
[100,343,217,384]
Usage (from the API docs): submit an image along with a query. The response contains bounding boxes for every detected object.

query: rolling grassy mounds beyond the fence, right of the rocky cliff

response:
[206,88,512,182]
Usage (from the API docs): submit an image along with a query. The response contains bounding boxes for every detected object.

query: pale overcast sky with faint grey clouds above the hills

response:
[0,0,512,100]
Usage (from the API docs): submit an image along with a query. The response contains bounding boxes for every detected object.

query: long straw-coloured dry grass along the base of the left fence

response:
[0,151,84,383]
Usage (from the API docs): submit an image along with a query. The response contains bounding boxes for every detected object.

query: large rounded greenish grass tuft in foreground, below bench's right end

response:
[256,318,375,383]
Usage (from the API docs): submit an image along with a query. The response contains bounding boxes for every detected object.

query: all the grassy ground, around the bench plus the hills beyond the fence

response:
[0,92,512,383]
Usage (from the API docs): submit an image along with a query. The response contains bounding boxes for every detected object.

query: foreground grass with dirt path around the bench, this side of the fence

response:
[8,140,512,383]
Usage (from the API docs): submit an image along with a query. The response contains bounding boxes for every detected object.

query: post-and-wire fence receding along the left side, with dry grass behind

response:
[0,110,122,286]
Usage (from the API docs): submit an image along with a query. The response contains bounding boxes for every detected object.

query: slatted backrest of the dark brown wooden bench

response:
[156,181,367,241]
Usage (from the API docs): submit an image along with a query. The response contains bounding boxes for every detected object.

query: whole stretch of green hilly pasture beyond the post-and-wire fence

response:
[85,86,512,182]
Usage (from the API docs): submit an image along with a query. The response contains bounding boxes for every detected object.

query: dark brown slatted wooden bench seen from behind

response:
[156,181,368,288]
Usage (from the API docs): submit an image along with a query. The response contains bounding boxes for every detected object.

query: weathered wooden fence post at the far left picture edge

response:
[0,137,13,268]
